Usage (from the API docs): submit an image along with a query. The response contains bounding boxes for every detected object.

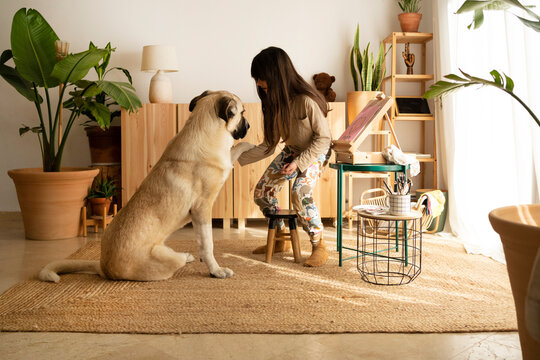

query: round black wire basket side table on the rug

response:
[356,210,422,285]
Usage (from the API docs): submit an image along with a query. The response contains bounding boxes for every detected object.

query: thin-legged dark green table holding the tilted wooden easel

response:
[330,163,409,266]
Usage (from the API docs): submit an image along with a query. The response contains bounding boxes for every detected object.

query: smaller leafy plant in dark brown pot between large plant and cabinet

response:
[64,42,142,164]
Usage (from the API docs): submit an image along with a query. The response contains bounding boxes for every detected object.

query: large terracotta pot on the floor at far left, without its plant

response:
[8,168,99,240]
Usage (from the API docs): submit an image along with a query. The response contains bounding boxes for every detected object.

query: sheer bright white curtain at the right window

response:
[433,0,540,262]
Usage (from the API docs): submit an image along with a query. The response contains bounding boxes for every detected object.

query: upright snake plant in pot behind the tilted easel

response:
[347,25,386,124]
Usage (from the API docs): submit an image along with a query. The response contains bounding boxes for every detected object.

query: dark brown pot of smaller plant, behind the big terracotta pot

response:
[84,126,122,164]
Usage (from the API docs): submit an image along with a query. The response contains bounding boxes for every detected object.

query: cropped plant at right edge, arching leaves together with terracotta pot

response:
[424,0,540,359]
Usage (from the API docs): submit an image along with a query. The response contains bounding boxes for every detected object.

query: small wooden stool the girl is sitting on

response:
[264,209,301,263]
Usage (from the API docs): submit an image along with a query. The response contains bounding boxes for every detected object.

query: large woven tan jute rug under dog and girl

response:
[0,228,517,334]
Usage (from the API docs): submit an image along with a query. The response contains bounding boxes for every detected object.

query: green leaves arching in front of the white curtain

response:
[424,0,540,126]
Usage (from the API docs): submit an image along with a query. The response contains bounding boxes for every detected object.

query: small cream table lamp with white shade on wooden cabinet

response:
[141,45,178,103]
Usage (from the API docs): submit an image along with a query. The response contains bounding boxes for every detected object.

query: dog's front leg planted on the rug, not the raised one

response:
[192,211,234,279]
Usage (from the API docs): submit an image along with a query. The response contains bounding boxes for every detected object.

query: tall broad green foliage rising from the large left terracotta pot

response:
[0,8,141,172]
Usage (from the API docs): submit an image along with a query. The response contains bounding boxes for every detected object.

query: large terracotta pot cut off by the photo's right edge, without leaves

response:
[489,204,540,359]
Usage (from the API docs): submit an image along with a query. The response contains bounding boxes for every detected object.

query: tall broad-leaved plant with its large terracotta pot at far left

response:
[0,8,139,240]
